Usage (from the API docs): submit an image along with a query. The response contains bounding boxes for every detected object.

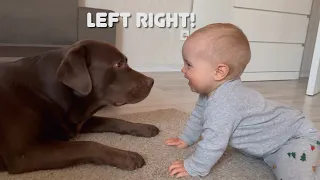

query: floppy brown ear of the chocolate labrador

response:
[57,45,92,96]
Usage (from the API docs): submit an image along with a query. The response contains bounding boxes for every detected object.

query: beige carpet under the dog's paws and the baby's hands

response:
[0,109,275,180]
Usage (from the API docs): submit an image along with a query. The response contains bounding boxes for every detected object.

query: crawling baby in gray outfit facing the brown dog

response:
[165,23,320,180]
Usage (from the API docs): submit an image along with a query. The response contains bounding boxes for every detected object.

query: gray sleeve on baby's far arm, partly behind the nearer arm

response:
[179,95,204,146]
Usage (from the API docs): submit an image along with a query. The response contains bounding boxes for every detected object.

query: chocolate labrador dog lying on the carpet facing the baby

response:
[0,40,159,174]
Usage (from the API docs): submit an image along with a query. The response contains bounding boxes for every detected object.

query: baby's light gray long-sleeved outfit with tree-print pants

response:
[180,79,320,180]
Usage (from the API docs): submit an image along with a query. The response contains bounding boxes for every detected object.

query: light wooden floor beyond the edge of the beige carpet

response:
[97,72,320,129]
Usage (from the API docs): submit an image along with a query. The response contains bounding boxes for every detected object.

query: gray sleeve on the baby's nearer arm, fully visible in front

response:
[184,102,240,176]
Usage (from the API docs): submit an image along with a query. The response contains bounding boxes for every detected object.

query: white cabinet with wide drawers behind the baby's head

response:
[194,0,312,81]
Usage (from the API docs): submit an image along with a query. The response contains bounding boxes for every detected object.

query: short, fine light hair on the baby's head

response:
[190,23,251,78]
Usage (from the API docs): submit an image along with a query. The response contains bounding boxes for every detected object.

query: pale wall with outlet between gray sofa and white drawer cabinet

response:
[79,0,192,71]
